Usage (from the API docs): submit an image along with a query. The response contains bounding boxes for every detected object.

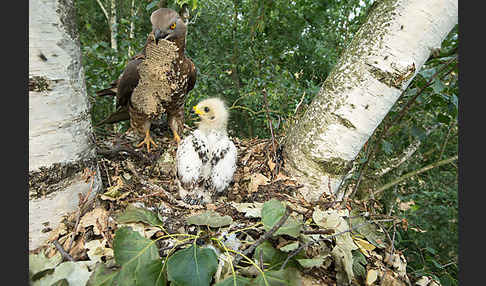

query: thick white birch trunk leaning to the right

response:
[284,0,458,201]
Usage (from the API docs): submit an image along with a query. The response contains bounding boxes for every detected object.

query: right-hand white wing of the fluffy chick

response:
[209,136,237,192]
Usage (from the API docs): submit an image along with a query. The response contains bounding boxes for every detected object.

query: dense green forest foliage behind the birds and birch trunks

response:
[75,0,459,285]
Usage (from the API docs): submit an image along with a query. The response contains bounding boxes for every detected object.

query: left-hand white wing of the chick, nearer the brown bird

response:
[176,130,209,184]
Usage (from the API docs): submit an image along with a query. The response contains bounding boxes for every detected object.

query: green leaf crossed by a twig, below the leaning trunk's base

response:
[262,199,302,238]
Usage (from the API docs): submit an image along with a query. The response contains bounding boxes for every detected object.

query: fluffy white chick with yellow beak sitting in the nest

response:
[176,98,237,204]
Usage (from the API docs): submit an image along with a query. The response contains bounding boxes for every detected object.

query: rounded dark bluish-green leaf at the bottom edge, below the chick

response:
[167,245,218,286]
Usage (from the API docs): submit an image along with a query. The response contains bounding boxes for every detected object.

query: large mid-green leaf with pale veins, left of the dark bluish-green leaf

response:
[113,227,160,286]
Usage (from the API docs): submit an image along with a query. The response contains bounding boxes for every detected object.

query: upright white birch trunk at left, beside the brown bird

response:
[29,0,101,249]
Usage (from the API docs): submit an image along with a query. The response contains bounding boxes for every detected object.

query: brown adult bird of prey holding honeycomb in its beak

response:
[96,8,196,152]
